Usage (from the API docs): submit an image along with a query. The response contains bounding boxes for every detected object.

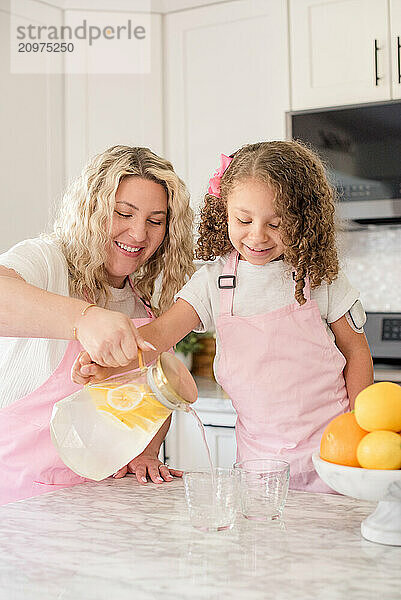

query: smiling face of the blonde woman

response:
[105,177,167,288]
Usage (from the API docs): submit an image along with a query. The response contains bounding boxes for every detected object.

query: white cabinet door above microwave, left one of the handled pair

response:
[290,0,391,110]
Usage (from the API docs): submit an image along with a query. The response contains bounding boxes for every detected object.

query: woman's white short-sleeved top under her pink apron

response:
[0,238,147,408]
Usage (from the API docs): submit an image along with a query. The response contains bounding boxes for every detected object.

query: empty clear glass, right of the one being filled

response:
[234,458,290,521]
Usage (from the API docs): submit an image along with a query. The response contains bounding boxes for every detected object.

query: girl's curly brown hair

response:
[195,141,339,304]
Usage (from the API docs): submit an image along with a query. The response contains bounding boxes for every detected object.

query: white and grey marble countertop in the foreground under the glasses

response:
[0,476,401,600]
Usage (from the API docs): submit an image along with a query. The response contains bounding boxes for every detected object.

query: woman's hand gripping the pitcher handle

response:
[76,306,155,367]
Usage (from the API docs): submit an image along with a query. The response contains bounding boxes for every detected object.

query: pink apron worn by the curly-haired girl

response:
[216,251,350,493]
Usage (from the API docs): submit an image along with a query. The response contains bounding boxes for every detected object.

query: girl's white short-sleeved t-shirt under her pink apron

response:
[175,256,359,376]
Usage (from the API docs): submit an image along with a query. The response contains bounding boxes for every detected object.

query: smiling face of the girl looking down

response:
[227,179,284,265]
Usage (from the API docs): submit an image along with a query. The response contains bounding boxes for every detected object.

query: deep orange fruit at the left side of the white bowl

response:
[320,412,368,467]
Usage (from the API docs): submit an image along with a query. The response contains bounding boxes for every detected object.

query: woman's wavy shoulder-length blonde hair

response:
[51,146,194,314]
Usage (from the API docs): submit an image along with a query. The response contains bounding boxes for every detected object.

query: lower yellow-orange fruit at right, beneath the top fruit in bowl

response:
[357,431,401,469]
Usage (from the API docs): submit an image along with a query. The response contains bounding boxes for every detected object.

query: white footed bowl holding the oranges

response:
[312,452,401,546]
